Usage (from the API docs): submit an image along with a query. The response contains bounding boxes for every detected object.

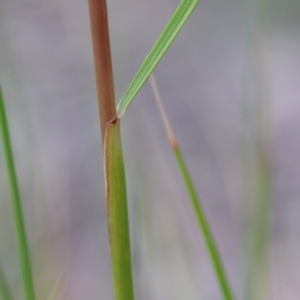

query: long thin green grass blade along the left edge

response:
[0,87,35,300]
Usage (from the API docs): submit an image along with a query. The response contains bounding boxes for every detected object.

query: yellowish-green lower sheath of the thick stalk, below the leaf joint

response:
[104,119,134,300]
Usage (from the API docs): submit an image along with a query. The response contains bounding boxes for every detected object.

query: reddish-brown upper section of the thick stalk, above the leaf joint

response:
[89,0,116,143]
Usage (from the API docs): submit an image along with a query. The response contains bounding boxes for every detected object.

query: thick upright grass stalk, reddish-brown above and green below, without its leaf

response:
[89,0,134,300]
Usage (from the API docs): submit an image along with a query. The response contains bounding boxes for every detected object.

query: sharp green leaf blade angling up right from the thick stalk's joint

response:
[117,0,199,117]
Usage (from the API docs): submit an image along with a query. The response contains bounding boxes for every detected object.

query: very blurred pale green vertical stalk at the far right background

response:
[244,0,279,300]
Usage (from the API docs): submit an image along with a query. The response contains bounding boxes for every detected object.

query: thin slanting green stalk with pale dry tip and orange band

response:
[150,75,234,300]
